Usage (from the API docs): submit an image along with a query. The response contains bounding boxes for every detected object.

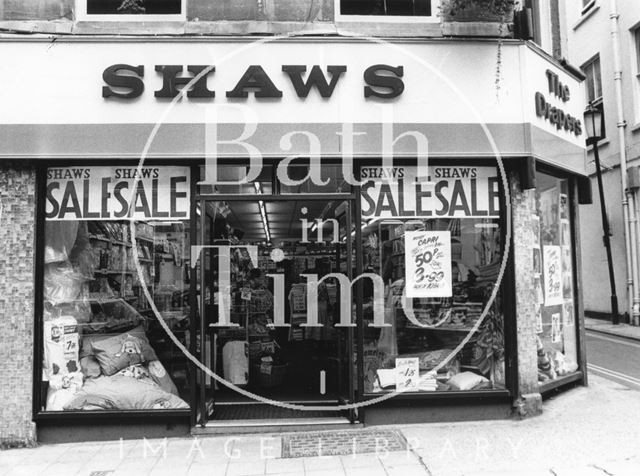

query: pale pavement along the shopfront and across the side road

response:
[0,319,640,476]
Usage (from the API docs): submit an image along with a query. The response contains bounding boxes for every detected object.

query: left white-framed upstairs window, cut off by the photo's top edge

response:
[76,0,186,21]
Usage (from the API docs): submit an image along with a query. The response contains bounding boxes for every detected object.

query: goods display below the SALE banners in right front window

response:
[363,219,505,393]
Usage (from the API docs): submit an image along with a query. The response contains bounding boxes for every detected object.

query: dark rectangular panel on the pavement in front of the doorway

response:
[282,430,407,458]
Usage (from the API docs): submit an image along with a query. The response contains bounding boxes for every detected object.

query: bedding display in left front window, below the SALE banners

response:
[41,220,190,412]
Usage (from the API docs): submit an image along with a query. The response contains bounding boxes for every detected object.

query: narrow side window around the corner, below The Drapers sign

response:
[532,172,578,384]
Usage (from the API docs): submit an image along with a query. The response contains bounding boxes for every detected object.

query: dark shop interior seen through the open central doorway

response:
[198,195,354,418]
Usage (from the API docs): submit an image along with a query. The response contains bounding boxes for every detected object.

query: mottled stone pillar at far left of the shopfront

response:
[0,161,36,448]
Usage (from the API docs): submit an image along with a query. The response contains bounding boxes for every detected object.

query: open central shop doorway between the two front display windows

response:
[194,194,357,426]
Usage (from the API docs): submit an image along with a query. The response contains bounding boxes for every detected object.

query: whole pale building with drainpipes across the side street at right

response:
[564,1,640,325]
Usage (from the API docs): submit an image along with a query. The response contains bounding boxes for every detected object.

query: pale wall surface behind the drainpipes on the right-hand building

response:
[563,0,640,318]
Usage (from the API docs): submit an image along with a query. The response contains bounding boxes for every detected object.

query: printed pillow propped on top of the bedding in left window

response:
[91,332,158,375]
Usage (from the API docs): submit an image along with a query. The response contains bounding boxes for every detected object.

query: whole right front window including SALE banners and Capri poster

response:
[362,166,505,393]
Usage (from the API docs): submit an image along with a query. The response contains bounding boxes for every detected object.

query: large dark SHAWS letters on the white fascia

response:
[102,64,404,100]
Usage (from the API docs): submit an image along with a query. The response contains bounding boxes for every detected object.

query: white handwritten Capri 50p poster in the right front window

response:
[404,231,452,298]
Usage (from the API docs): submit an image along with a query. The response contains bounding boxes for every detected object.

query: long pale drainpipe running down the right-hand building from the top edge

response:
[609,0,640,322]
